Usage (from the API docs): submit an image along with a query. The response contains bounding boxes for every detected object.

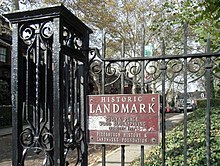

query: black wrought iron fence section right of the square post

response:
[90,28,220,166]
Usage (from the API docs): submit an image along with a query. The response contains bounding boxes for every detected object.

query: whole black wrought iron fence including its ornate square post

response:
[3,5,219,166]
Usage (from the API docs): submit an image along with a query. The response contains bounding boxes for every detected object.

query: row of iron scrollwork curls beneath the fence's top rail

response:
[90,49,220,93]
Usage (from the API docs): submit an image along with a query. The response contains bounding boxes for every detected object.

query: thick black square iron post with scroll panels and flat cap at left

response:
[6,5,92,166]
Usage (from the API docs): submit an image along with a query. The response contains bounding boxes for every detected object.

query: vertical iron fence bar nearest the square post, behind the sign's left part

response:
[101,30,106,166]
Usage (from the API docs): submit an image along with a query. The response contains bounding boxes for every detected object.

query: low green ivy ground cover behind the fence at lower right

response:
[133,108,220,166]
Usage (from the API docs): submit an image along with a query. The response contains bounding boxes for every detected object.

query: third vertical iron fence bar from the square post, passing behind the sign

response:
[141,24,145,166]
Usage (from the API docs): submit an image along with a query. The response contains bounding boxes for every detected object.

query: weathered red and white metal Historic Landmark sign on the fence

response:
[88,94,160,145]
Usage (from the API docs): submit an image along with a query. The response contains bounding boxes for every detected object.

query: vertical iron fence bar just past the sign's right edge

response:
[161,39,166,166]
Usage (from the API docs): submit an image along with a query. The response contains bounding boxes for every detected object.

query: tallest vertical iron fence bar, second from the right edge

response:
[184,18,188,166]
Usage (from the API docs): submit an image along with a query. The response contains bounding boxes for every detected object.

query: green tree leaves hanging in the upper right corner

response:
[163,0,220,52]
